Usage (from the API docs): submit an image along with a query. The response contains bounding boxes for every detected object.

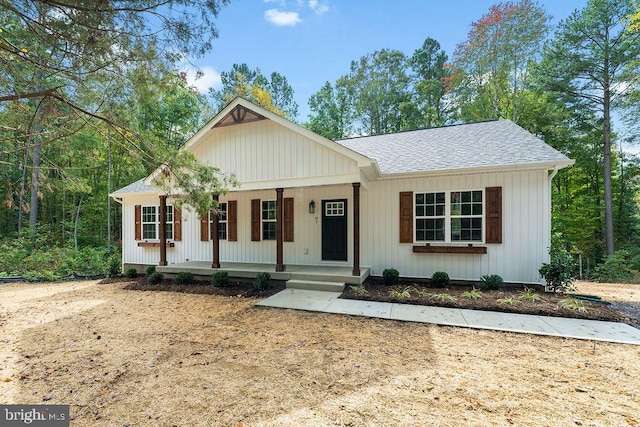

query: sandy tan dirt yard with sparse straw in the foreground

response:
[0,281,640,427]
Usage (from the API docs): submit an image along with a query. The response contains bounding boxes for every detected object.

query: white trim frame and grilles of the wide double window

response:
[412,188,487,245]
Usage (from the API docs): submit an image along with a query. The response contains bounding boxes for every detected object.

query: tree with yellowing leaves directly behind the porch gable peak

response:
[209,63,298,120]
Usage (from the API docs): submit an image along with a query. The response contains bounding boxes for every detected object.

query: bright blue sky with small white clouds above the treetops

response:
[182,0,587,121]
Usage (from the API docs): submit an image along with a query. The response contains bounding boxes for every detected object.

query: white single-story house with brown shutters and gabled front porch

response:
[111,98,573,284]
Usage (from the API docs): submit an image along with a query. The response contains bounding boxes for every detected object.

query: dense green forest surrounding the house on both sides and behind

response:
[0,0,640,281]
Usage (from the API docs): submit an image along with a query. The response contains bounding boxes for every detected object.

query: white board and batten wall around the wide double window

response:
[360,171,550,283]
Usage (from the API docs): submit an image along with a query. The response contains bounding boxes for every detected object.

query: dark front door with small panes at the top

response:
[322,199,347,261]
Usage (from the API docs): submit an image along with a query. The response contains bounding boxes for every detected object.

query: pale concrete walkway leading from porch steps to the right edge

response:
[256,289,640,345]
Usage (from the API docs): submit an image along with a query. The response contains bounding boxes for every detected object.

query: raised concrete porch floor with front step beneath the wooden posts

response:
[156,261,369,285]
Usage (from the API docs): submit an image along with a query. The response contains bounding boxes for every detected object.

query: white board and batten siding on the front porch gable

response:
[192,120,360,188]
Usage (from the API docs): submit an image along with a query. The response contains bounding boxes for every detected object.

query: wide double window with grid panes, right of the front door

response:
[415,190,483,242]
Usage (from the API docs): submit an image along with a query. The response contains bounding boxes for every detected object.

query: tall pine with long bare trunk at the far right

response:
[539,0,640,255]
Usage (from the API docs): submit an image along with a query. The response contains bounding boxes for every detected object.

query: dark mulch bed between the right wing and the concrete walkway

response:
[341,277,640,326]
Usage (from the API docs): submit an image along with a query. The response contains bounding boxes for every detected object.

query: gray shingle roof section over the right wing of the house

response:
[336,120,572,174]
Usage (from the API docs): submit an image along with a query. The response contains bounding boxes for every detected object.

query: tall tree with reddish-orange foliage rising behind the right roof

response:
[453,0,550,121]
